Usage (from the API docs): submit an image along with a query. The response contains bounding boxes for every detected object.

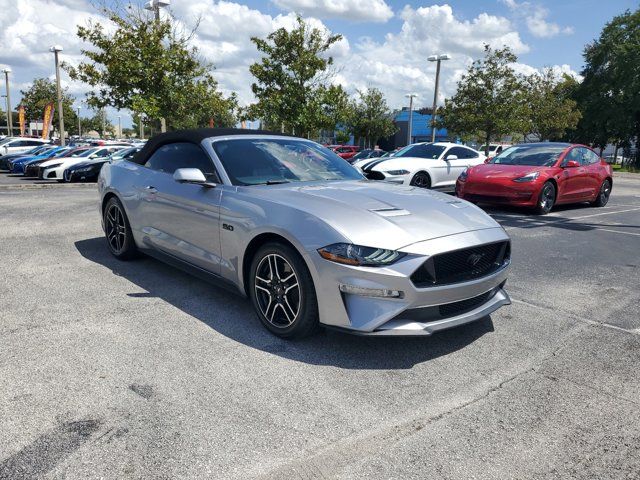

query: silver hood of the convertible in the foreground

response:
[239,180,500,249]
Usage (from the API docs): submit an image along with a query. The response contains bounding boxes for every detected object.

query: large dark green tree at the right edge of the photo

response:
[571,9,640,166]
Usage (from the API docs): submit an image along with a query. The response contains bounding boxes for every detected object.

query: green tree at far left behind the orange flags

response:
[15,78,78,135]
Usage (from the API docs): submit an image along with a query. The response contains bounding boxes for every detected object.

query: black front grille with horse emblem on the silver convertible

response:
[411,240,511,287]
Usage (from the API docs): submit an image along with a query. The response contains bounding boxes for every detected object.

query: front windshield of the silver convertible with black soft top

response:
[213,138,363,185]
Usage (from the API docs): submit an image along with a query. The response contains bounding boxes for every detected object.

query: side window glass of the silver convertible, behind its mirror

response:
[144,143,220,182]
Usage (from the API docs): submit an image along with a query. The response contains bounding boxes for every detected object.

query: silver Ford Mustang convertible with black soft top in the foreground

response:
[98,129,510,338]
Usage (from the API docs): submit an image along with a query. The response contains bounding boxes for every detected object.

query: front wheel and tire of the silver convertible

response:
[249,242,319,338]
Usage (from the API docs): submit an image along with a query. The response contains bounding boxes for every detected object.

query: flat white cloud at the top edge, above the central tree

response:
[273,0,393,22]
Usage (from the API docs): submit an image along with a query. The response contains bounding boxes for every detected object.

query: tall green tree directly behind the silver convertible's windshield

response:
[247,17,342,136]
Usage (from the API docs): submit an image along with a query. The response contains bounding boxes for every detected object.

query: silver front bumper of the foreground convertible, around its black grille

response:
[308,227,511,335]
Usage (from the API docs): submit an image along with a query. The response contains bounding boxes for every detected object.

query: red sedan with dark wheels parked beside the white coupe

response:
[456,142,613,215]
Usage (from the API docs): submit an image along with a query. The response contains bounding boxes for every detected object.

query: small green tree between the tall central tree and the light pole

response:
[350,88,397,148]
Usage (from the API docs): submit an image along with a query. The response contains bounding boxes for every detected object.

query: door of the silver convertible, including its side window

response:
[137,142,222,274]
